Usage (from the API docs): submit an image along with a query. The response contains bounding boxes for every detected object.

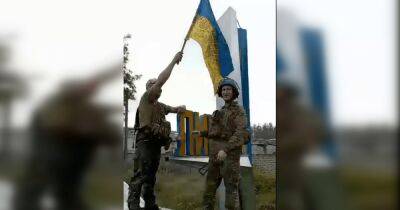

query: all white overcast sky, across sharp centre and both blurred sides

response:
[0,0,397,129]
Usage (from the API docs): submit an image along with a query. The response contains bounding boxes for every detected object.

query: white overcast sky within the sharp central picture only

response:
[127,0,275,127]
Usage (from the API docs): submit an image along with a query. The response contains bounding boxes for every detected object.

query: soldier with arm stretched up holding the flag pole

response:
[128,52,186,210]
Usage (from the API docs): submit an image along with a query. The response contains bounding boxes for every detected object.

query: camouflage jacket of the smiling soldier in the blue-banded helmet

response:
[208,101,250,155]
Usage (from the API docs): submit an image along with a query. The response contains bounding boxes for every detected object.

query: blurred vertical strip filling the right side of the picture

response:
[276,0,399,210]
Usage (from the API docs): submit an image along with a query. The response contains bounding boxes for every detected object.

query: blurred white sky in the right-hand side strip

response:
[278,0,398,126]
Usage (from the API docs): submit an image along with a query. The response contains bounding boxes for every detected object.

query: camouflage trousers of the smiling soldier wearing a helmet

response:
[203,154,240,210]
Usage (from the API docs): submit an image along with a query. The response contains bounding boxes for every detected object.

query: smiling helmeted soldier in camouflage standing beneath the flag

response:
[201,78,249,210]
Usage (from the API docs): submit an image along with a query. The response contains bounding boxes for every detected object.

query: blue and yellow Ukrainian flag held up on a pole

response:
[187,0,233,92]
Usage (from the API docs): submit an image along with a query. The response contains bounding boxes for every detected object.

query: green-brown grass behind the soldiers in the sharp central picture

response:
[124,159,276,210]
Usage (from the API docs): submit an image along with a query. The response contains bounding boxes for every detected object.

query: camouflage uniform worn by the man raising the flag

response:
[128,89,172,209]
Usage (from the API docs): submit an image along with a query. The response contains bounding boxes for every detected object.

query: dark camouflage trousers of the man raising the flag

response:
[128,141,161,210]
